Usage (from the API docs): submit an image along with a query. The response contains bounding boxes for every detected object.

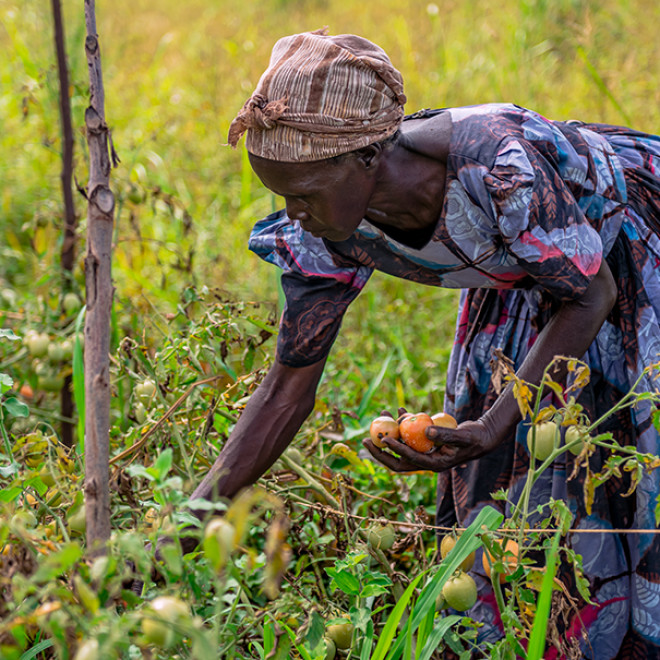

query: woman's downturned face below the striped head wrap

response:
[250,154,378,241]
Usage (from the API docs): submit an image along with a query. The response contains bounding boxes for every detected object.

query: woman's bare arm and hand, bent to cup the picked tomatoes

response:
[365,260,616,472]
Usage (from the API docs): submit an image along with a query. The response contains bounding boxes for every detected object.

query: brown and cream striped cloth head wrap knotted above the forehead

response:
[228,30,406,163]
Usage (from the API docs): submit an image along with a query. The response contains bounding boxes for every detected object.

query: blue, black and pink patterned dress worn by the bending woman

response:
[250,104,660,660]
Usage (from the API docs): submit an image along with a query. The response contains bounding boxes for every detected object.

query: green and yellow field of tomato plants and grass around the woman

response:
[0,0,660,660]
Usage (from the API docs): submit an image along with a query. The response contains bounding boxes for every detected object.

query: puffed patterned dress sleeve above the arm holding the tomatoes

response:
[484,139,603,300]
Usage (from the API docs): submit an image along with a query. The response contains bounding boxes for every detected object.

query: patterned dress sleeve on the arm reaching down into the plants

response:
[249,211,373,367]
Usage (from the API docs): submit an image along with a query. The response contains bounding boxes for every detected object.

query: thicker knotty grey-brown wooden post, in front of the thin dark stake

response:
[85,0,115,555]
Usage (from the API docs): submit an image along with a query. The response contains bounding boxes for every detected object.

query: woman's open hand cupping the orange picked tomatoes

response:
[363,420,500,472]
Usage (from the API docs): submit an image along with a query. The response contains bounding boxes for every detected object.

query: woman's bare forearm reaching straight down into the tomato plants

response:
[192,359,325,510]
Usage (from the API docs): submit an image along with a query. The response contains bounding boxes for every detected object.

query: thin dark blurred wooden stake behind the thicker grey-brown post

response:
[51,0,77,447]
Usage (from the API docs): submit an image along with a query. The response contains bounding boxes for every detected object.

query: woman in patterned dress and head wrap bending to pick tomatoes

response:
[194,31,660,660]
